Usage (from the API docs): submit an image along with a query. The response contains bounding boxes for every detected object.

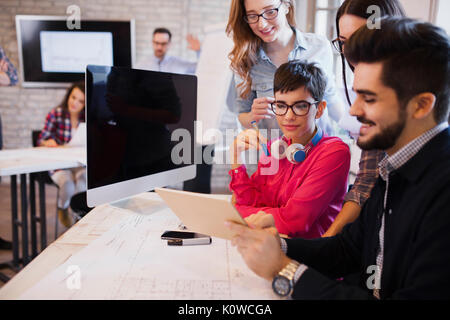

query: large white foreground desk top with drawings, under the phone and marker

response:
[0,193,277,300]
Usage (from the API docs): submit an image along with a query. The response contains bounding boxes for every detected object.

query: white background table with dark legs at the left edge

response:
[0,147,86,281]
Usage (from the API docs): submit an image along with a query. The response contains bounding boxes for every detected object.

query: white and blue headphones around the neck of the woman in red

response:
[270,128,323,164]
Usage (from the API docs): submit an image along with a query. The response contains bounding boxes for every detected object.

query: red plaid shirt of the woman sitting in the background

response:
[38,107,84,145]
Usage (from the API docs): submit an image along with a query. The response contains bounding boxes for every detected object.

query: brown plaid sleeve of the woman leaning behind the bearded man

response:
[344,150,386,207]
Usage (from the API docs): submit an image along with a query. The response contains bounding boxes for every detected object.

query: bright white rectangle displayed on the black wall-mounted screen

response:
[40,31,113,73]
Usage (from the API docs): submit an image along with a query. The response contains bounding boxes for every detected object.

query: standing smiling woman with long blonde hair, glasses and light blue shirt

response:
[227,0,344,134]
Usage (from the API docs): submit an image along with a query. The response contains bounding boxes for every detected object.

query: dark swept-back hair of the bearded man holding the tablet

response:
[345,17,450,123]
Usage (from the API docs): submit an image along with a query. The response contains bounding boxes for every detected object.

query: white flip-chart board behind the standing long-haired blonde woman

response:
[196,24,233,145]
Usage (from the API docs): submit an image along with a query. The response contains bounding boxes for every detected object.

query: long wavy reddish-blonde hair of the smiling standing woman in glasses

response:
[226,0,295,98]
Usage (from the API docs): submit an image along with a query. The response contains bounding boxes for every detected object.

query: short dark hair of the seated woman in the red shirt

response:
[273,60,327,101]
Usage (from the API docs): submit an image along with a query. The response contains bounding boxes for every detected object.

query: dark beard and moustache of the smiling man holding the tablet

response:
[357,110,406,150]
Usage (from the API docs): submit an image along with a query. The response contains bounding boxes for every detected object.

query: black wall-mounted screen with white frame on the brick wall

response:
[16,15,134,87]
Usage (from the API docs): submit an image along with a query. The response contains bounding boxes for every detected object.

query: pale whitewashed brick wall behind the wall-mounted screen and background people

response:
[0,0,234,191]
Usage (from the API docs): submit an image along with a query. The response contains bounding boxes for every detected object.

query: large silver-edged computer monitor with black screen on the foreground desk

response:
[86,65,196,207]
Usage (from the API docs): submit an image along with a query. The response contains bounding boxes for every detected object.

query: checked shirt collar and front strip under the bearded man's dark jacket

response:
[373,122,448,299]
